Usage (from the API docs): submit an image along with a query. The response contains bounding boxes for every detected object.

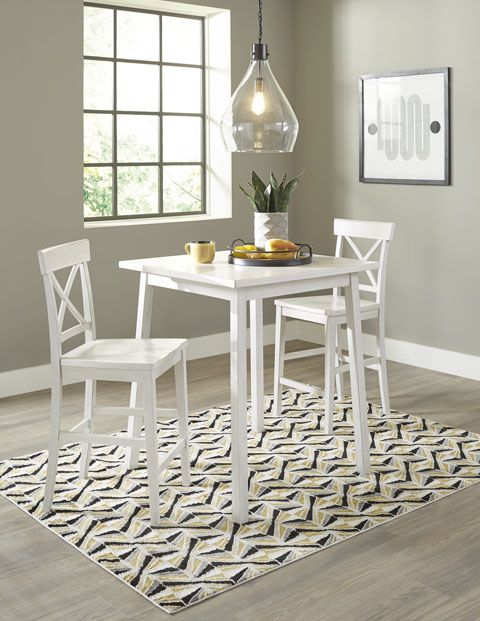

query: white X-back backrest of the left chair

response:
[38,239,95,365]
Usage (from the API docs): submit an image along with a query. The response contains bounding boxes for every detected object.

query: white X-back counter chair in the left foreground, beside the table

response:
[38,239,190,526]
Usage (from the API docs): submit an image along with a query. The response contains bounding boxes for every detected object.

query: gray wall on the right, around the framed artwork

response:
[293,0,480,355]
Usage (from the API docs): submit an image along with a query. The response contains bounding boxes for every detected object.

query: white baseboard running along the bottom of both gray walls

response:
[0,320,480,398]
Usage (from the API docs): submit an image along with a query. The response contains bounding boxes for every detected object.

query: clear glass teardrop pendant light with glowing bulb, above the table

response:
[221,0,298,153]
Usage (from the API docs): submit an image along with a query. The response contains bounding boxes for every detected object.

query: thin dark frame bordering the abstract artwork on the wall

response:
[359,67,451,185]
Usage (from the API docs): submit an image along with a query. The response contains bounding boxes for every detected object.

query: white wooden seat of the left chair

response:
[61,339,187,371]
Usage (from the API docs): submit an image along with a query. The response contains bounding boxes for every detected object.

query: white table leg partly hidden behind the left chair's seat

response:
[125,274,153,469]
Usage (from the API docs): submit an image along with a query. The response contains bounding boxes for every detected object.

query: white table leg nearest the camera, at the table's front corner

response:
[230,291,248,524]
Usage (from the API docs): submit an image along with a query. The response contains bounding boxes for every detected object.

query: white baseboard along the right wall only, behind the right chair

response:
[294,321,480,380]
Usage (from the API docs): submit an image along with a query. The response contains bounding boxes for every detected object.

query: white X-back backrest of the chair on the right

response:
[333,218,395,305]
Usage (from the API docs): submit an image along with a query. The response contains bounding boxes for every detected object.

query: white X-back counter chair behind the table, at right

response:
[273,219,395,433]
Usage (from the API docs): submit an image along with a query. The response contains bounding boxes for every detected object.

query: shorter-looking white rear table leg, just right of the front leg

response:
[250,299,265,433]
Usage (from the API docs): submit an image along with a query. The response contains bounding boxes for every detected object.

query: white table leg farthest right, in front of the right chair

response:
[345,274,370,476]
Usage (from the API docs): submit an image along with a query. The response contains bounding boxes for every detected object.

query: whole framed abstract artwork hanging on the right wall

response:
[359,67,450,185]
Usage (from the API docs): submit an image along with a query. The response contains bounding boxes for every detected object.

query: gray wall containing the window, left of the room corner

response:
[0,0,293,371]
